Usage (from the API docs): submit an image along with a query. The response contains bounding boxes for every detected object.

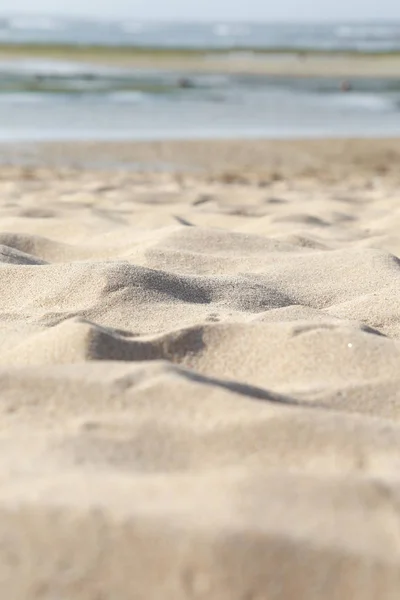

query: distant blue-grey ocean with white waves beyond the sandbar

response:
[0,13,400,52]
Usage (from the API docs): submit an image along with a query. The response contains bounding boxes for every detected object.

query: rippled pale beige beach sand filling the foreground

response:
[0,140,400,600]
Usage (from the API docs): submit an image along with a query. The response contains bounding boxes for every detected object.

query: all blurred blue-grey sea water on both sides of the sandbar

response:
[0,13,400,141]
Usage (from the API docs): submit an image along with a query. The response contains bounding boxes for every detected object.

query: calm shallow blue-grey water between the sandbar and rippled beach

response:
[0,59,400,141]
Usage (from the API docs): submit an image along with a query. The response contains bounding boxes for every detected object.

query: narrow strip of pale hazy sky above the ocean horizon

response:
[0,0,400,21]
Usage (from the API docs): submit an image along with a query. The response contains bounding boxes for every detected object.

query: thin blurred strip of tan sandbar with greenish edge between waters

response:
[0,44,400,79]
